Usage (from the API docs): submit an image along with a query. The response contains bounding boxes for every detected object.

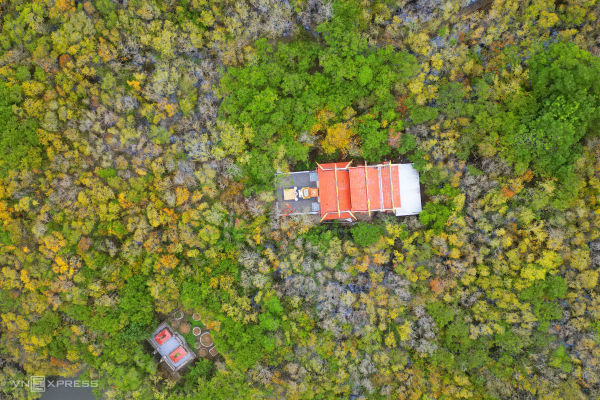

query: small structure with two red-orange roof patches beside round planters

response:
[148,322,196,373]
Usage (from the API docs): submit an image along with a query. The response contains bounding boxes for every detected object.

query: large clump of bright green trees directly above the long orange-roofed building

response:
[220,3,417,189]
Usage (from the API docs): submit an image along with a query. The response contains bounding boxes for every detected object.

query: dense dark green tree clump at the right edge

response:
[501,43,600,181]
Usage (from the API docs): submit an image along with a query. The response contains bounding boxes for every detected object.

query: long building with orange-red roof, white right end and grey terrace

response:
[276,162,422,221]
